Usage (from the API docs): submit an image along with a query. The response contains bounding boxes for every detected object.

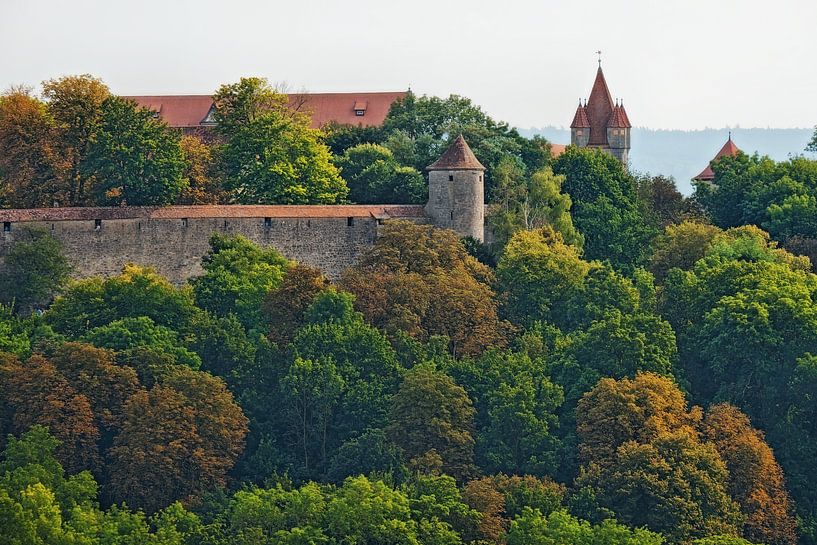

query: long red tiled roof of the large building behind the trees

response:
[124,92,406,128]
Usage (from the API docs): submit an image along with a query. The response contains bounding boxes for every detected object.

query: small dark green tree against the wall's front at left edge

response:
[0,224,72,314]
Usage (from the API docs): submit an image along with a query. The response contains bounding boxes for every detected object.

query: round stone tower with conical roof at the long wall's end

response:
[425,135,485,241]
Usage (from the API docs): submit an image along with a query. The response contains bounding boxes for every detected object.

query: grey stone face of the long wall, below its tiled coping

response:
[0,212,424,284]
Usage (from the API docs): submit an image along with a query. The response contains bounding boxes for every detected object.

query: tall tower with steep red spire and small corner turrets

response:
[570,61,632,166]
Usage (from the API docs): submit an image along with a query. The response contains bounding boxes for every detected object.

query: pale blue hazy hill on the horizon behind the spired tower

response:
[520,127,814,194]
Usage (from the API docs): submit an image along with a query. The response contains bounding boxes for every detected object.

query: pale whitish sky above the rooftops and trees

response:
[0,0,817,129]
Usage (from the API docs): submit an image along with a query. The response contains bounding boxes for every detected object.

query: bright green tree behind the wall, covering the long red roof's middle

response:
[213,78,349,204]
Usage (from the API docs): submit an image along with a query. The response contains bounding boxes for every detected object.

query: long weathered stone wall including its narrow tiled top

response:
[0,205,426,283]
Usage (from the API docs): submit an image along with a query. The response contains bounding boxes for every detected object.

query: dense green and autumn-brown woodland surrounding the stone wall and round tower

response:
[0,76,817,545]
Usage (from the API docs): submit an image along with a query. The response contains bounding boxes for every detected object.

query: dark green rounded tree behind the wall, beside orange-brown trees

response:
[81,96,187,206]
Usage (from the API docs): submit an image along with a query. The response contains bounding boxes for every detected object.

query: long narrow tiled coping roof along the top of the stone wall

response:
[0,204,424,222]
